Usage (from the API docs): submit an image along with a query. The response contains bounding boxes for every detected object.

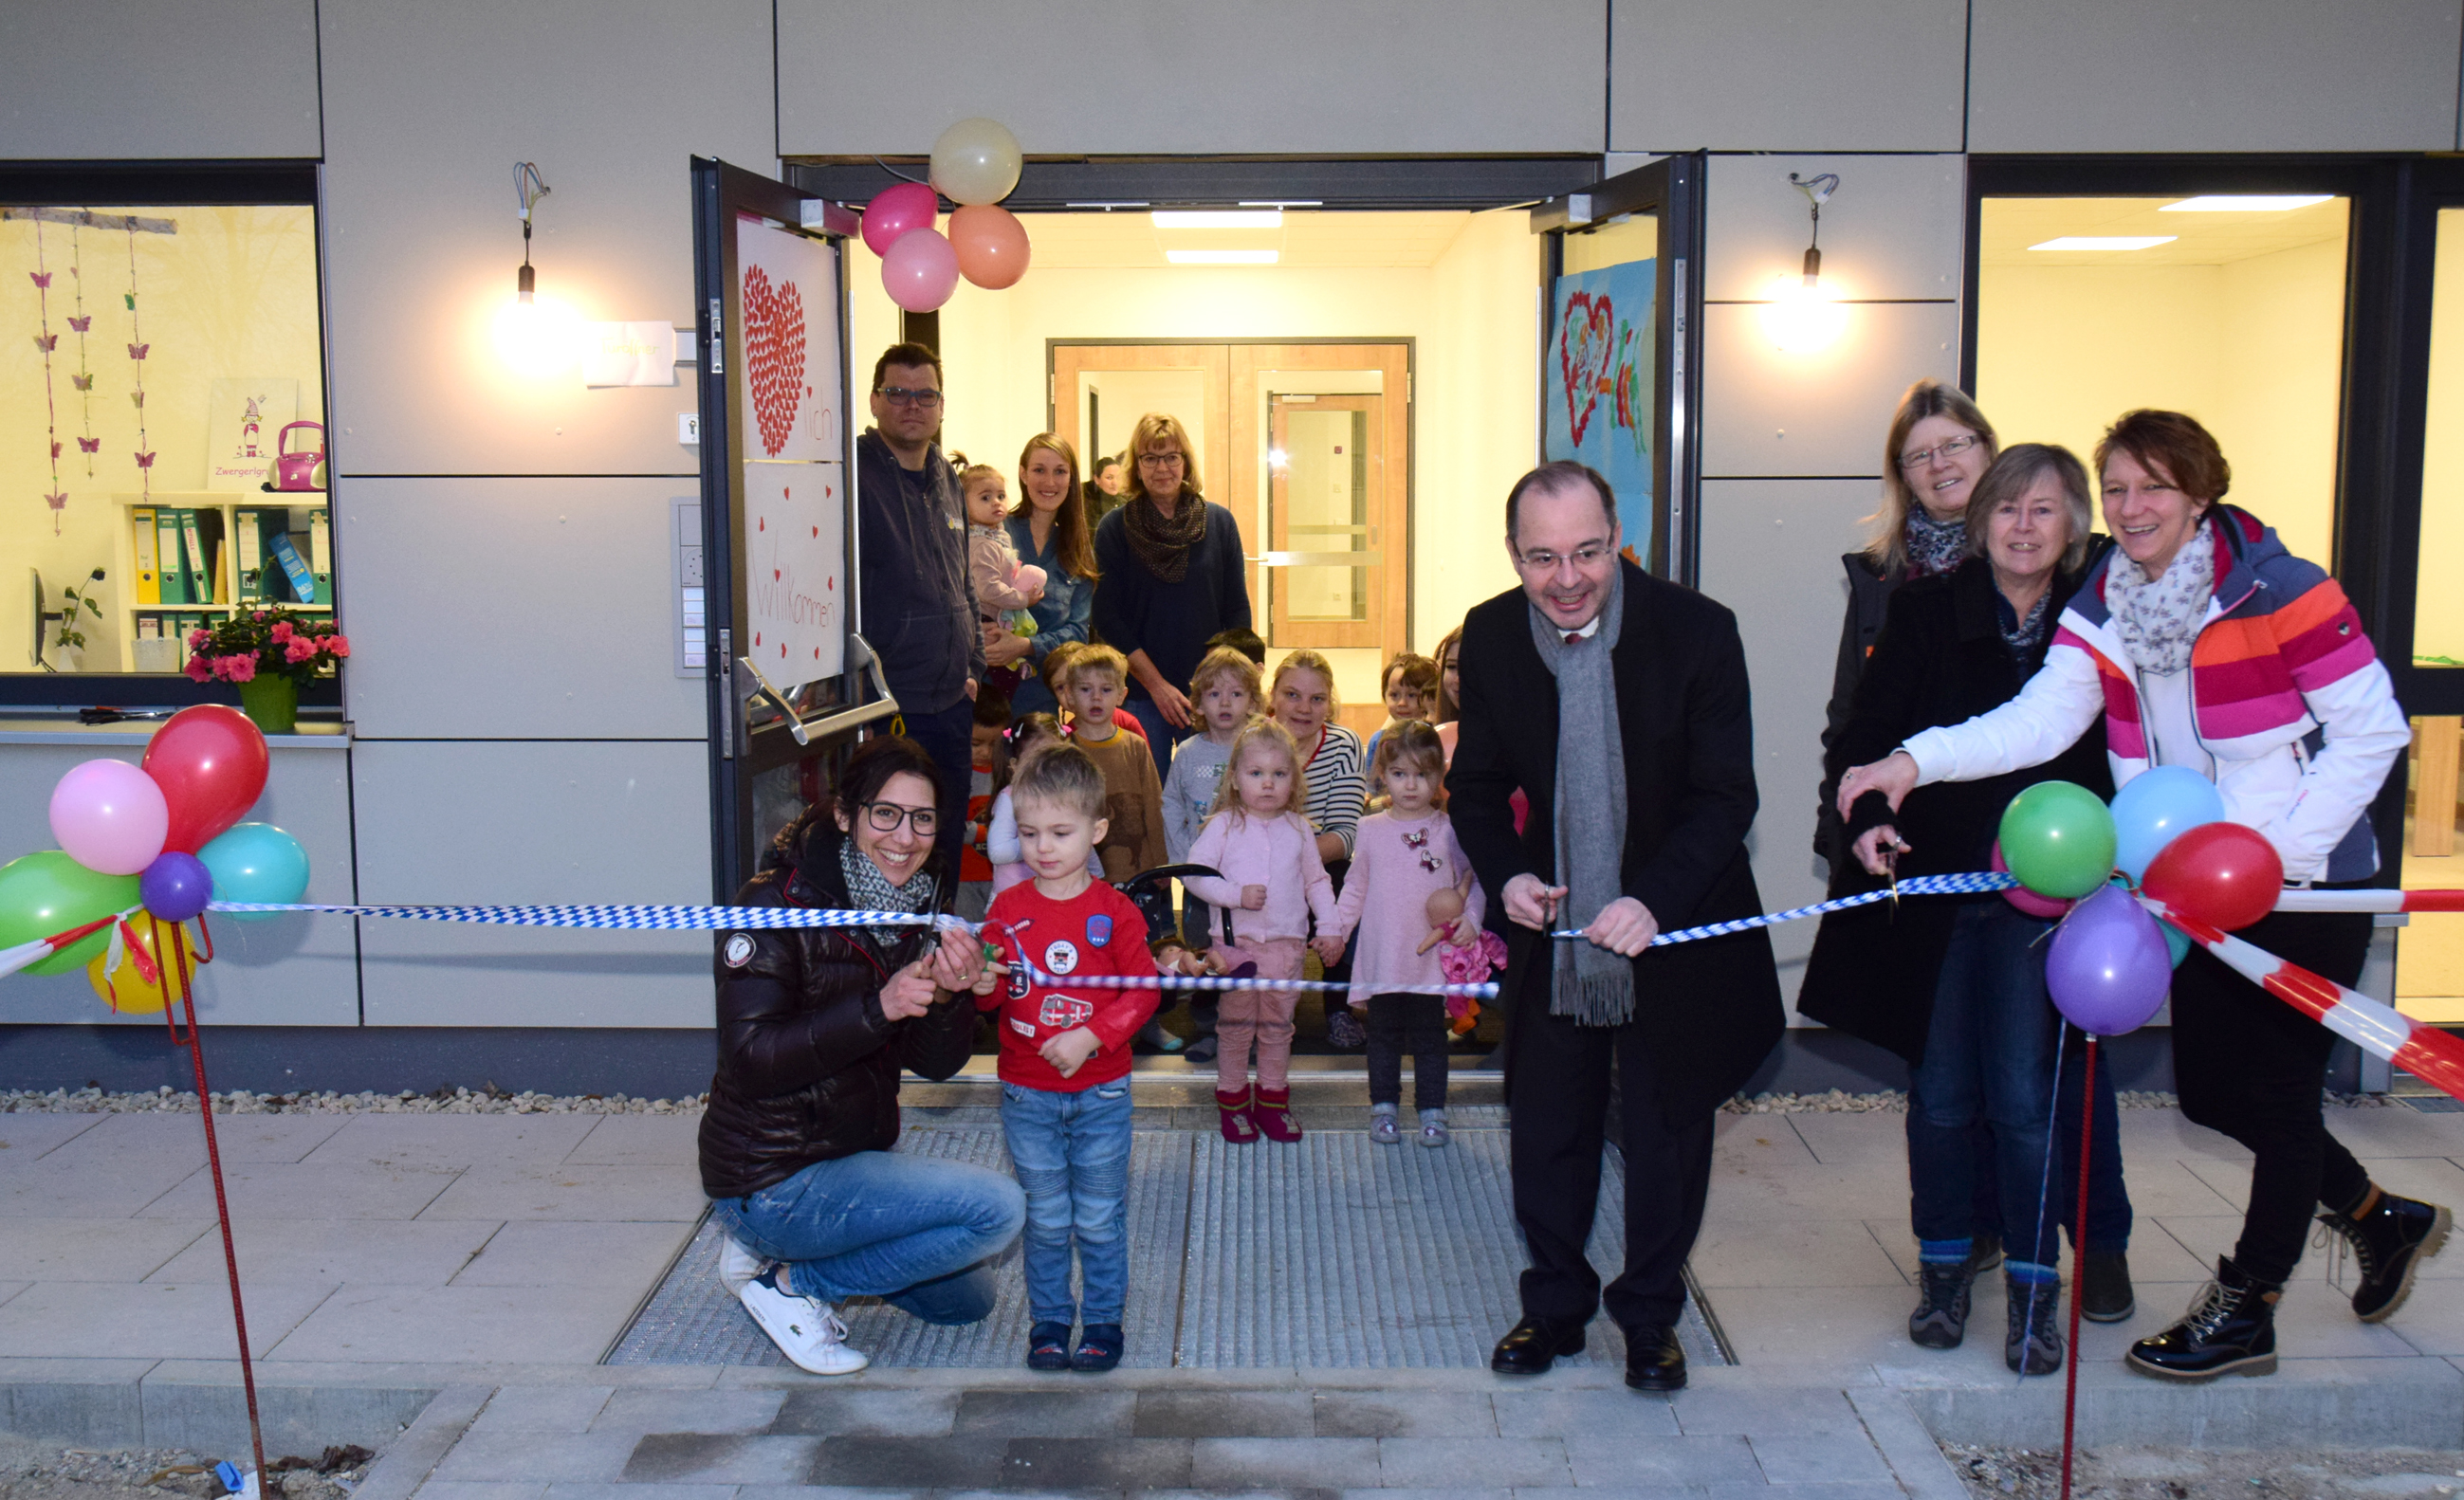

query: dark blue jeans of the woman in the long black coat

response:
[1907,897,2063,1266]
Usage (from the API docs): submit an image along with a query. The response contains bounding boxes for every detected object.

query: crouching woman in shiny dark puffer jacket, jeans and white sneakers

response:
[702,739,1025,1375]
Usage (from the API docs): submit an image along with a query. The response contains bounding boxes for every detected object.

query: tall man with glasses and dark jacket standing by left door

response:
[855,342,1025,872]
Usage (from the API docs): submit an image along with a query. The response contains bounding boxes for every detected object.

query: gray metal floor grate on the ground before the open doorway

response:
[606,1108,1727,1369]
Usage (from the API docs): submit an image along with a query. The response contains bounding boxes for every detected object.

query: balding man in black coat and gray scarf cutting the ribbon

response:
[1446,463,1784,1392]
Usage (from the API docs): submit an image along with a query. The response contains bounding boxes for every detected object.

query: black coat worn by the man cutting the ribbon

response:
[1446,564,1787,1125]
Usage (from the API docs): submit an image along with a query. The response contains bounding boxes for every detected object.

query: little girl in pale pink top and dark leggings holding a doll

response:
[1321,720,1496,1145]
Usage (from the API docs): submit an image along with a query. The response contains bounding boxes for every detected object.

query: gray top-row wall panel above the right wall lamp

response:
[1609,0,1966,150]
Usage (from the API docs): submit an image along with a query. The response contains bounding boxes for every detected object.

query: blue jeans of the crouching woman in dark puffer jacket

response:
[709,1150,1027,1323]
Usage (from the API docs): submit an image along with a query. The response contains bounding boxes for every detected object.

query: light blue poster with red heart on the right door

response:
[1540,261,1658,561]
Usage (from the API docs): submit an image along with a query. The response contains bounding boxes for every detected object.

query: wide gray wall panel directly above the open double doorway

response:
[779,0,1607,155]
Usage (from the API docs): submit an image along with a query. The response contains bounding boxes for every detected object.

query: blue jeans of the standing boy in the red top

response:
[1001,1079,1129,1326]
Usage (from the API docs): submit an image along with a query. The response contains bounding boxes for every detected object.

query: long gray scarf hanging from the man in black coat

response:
[1530,566,1633,1027]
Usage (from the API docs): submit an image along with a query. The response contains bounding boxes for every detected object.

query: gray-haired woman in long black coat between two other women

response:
[1796,444,2126,1375]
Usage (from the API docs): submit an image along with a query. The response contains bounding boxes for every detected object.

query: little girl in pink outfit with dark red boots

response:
[1180,720,1343,1145]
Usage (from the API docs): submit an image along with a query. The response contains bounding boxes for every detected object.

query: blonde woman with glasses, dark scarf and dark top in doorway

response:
[1094,412,1249,776]
